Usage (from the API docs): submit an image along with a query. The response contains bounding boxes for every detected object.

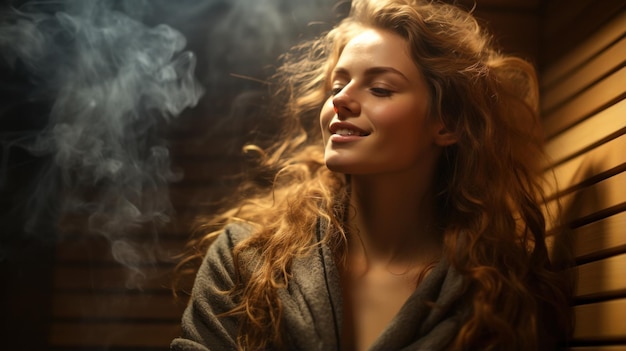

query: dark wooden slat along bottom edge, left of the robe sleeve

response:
[49,323,180,351]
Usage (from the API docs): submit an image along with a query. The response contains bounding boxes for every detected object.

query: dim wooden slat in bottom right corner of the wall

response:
[574,298,626,341]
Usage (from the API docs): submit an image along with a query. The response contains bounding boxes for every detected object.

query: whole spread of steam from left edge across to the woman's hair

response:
[0,0,348,286]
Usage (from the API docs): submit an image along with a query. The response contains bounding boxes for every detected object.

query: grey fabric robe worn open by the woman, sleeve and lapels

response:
[171,224,470,351]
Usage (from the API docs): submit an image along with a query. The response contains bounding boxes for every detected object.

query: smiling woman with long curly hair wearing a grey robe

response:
[172,0,569,350]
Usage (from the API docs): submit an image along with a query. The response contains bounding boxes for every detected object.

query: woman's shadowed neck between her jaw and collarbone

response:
[347,175,441,263]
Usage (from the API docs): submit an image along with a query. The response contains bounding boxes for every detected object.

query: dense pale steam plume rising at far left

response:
[0,1,202,282]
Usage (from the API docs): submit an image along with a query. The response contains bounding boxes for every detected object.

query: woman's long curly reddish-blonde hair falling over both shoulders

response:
[179,0,570,350]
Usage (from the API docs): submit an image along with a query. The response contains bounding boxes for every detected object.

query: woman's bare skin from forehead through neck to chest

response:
[320,28,455,350]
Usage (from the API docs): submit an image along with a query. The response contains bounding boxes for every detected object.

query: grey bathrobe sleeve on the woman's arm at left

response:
[170,225,250,351]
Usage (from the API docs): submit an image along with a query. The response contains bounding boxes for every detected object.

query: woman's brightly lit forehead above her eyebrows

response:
[336,28,421,76]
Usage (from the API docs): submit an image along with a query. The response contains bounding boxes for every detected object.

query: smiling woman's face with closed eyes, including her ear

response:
[320,29,442,174]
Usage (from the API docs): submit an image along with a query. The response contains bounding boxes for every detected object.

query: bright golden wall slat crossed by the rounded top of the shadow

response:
[544,134,626,197]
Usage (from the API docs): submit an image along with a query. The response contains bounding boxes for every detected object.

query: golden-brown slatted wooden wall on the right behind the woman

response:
[540,0,626,351]
